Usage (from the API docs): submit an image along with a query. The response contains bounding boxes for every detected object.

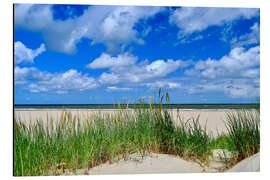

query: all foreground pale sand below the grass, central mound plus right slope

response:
[81,153,260,174]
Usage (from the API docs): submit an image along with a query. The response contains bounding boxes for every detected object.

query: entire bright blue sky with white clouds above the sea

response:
[14,4,260,104]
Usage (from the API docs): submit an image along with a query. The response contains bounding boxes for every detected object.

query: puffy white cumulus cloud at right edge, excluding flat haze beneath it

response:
[185,46,260,79]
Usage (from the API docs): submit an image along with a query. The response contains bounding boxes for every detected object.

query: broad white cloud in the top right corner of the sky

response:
[170,7,259,36]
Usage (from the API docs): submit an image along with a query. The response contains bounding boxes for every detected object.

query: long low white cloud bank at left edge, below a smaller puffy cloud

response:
[14,67,99,94]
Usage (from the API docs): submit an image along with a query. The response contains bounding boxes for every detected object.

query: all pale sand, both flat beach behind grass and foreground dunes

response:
[14,109,260,175]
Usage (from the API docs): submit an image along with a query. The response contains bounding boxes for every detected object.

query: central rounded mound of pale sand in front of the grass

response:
[87,154,203,174]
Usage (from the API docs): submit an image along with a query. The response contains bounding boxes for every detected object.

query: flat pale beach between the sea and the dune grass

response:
[14,109,253,137]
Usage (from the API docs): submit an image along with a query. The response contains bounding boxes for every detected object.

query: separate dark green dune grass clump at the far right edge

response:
[210,109,260,167]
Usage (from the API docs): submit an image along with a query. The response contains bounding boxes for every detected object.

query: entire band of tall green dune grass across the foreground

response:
[14,92,260,176]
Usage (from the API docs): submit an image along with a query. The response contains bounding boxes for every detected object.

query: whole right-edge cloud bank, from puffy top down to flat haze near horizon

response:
[181,46,260,98]
